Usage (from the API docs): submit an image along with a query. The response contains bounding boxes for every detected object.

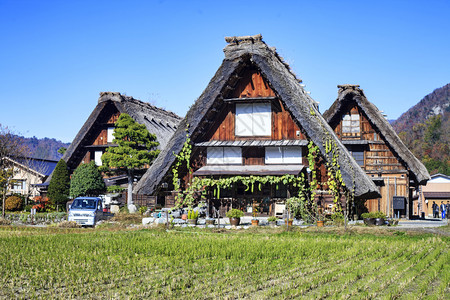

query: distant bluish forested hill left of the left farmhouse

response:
[20,136,70,160]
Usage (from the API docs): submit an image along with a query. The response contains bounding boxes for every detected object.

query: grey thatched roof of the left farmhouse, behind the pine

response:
[58,92,181,173]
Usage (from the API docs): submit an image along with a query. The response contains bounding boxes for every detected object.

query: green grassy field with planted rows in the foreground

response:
[0,227,450,299]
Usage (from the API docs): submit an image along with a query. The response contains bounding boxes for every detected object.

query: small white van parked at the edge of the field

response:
[68,197,103,226]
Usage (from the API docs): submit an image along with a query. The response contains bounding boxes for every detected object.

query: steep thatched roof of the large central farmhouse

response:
[135,35,378,197]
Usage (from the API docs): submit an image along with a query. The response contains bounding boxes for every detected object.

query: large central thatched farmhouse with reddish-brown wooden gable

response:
[135,35,378,216]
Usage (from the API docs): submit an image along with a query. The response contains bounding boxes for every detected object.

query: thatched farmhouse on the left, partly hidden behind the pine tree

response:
[55,92,181,204]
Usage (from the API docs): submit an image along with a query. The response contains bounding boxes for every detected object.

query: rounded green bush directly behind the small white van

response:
[70,161,106,198]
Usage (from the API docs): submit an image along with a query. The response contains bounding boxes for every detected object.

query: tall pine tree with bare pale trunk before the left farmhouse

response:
[102,114,159,212]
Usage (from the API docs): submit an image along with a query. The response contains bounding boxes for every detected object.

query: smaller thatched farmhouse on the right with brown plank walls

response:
[323,85,430,217]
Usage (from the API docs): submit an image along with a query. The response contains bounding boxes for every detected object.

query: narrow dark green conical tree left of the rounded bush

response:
[48,159,70,209]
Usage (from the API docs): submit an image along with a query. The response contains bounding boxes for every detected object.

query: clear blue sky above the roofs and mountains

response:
[0,0,450,142]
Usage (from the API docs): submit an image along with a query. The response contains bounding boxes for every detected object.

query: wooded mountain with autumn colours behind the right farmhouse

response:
[392,83,450,175]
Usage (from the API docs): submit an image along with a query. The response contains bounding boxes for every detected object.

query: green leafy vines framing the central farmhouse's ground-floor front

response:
[172,102,354,224]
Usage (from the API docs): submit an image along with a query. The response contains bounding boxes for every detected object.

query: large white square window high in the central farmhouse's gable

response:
[235,103,272,136]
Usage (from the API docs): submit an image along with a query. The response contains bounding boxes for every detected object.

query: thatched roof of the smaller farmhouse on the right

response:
[323,84,430,185]
